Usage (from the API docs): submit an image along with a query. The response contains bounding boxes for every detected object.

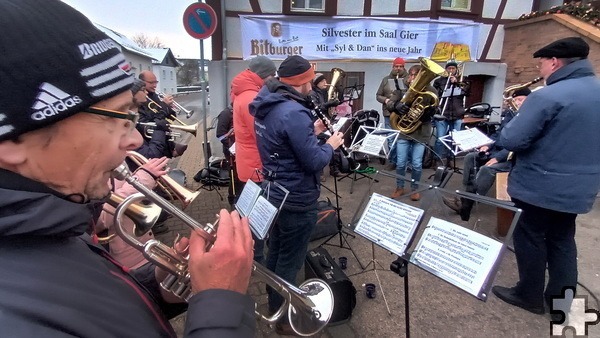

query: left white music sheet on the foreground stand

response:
[354,193,423,255]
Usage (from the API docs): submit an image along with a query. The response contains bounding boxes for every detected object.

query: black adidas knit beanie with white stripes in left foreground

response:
[0,0,133,141]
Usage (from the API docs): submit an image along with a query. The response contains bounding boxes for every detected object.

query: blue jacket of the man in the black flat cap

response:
[499,60,600,214]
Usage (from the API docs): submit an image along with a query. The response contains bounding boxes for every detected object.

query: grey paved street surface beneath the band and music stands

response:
[160,93,600,338]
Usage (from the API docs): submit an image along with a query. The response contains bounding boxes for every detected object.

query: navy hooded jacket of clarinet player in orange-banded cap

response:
[250,79,333,210]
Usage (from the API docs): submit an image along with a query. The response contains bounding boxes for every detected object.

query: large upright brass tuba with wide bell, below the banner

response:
[390,57,446,134]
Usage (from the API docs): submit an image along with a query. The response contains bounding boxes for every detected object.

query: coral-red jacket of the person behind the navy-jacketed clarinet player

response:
[231,69,264,182]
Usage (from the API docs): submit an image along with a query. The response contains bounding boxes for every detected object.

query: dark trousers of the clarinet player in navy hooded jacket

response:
[267,208,317,313]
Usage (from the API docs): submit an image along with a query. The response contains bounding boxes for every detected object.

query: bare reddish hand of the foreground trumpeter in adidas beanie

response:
[188,209,254,294]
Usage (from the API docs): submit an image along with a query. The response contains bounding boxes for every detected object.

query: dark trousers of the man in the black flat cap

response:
[513,199,577,306]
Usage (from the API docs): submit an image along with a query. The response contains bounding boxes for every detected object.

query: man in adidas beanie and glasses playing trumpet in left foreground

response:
[0,0,256,337]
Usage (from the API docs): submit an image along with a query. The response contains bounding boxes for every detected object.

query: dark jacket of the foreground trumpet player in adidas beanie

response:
[0,169,255,337]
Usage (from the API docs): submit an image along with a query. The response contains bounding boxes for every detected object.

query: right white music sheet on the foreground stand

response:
[410,217,502,297]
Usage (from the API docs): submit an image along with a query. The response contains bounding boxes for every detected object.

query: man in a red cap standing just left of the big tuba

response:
[377,57,408,170]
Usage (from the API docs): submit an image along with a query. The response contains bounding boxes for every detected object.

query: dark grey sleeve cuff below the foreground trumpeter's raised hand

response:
[184,289,256,338]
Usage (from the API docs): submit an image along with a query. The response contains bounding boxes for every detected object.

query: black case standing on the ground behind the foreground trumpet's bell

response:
[304,247,356,325]
